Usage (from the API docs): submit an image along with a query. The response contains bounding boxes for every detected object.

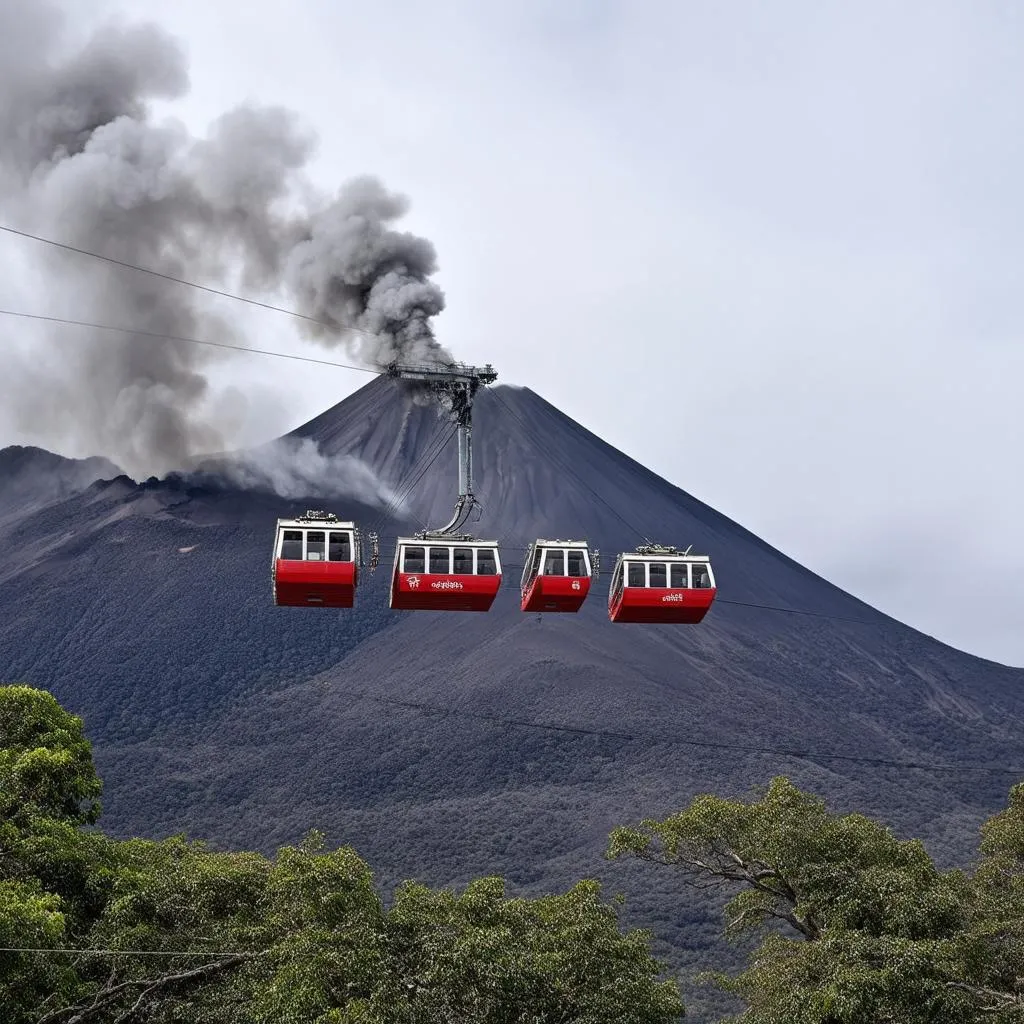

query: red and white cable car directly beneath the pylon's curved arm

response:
[391,537,502,611]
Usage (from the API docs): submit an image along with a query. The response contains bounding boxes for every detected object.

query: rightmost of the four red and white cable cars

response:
[608,545,718,623]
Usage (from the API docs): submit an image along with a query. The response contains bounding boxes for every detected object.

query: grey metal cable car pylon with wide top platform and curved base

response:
[384,362,498,540]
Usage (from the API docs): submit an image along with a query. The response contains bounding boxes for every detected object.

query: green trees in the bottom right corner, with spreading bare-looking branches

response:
[607,778,1024,1024]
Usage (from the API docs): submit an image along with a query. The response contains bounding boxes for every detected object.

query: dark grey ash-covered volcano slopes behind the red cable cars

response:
[0,378,1024,999]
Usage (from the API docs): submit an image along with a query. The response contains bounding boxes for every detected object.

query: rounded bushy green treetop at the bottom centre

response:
[364,878,683,1024]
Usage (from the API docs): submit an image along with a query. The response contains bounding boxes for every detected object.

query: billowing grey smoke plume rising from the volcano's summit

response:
[0,0,452,475]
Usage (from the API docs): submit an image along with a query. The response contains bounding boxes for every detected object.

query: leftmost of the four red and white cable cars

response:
[270,511,362,608]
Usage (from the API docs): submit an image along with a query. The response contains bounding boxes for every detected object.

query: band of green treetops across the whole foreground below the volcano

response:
[0,686,1024,1024]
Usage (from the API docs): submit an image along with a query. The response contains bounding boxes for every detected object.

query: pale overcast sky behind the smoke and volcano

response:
[0,0,1024,665]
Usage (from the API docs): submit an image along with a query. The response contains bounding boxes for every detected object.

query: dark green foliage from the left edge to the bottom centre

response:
[0,687,682,1024]
